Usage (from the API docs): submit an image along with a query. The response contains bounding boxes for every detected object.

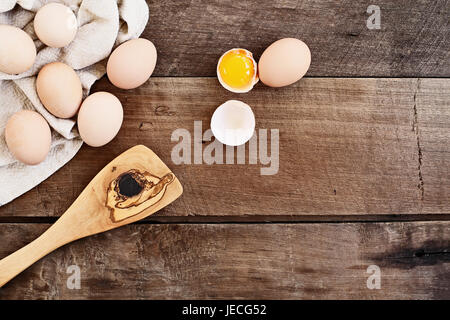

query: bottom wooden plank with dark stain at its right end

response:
[0,222,450,299]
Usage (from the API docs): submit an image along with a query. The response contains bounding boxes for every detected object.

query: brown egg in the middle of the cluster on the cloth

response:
[36,62,83,118]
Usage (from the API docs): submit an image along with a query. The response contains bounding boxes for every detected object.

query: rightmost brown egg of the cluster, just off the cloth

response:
[106,39,157,89]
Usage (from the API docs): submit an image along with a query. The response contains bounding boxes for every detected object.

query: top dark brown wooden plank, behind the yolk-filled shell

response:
[143,0,450,77]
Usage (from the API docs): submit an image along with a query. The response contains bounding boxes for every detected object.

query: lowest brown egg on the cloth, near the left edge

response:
[5,110,52,165]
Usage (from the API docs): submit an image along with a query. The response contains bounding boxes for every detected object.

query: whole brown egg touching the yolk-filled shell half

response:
[258,38,311,87]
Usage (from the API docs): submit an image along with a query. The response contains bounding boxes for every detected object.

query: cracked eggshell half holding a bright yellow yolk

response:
[217,48,259,93]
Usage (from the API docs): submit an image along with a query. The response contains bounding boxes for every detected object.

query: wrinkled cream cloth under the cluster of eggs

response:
[0,0,149,206]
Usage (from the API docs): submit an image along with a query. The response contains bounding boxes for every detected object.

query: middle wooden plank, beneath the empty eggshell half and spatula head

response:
[0,78,450,217]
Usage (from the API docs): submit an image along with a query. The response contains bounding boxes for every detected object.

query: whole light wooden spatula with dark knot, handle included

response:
[0,145,183,287]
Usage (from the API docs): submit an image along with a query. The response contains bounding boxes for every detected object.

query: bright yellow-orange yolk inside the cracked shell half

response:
[219,50,255,89]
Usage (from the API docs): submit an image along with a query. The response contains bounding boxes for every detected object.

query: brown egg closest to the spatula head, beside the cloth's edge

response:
[78,92,123,147]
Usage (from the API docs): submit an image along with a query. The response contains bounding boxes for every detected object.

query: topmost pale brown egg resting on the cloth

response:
[34,2,78,48]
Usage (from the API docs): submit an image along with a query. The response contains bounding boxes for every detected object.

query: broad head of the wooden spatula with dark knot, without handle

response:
[65,145,183,236]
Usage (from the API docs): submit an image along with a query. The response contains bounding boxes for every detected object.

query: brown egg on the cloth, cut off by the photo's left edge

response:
[0,25,36,74]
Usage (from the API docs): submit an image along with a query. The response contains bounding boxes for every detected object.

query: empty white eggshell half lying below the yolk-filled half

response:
[211,100,255,146]
